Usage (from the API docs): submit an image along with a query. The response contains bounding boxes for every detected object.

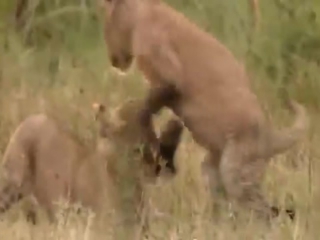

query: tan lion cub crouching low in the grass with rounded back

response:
[0,98,182,220]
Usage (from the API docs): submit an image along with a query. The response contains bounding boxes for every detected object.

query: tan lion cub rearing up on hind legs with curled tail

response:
[105,0,308,220]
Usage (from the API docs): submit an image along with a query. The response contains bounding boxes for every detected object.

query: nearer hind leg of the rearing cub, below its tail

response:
[219,141,275,219]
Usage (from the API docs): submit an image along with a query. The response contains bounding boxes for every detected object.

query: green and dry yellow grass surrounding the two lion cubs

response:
[0,0,320,240]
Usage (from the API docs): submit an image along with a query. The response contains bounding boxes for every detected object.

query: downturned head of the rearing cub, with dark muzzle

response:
[104,0,139,72]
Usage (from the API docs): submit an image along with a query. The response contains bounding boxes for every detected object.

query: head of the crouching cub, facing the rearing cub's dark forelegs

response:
[93,100,156,181]
